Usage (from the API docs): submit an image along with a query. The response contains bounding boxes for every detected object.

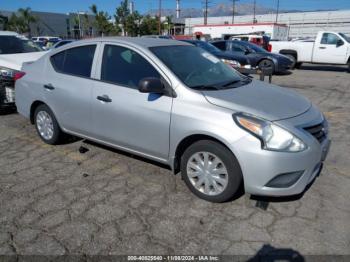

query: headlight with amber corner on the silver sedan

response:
[233,113,307,152]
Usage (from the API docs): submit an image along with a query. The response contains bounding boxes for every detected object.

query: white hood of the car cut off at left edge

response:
[0,51,47,70]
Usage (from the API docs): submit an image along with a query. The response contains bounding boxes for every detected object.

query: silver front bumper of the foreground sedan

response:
[233,107,331,196]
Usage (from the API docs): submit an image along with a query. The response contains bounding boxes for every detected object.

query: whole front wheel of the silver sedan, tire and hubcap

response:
[180,140,243,203]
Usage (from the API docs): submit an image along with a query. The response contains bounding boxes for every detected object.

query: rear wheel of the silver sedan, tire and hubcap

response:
[34,104,64,145]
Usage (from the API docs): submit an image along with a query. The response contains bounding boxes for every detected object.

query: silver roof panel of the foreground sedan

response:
[78,37,190,48]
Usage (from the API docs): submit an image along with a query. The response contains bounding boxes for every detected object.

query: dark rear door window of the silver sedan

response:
[51,45,96,77]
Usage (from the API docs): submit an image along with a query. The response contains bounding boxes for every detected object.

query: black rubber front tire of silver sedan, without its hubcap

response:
[180,140,243,203]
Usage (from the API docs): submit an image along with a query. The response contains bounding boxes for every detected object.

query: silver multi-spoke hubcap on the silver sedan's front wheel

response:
[186,152,228,196]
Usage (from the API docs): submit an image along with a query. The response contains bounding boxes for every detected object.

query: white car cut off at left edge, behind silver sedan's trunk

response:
[0,31,44,111]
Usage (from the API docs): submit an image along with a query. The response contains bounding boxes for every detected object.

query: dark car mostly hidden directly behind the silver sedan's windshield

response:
[181,40,255,74]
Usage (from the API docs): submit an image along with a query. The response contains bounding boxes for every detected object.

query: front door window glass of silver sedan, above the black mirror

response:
[101,45,160,89]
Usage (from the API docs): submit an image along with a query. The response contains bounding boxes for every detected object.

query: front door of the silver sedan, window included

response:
[92,43,173,160]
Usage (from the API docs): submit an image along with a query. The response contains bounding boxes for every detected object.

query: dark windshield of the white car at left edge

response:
[0,36,44,55]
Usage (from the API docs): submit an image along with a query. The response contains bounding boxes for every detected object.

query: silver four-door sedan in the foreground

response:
[16,38,330,202]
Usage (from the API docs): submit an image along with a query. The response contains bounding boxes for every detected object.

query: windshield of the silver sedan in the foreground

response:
[150,45,246,90]
